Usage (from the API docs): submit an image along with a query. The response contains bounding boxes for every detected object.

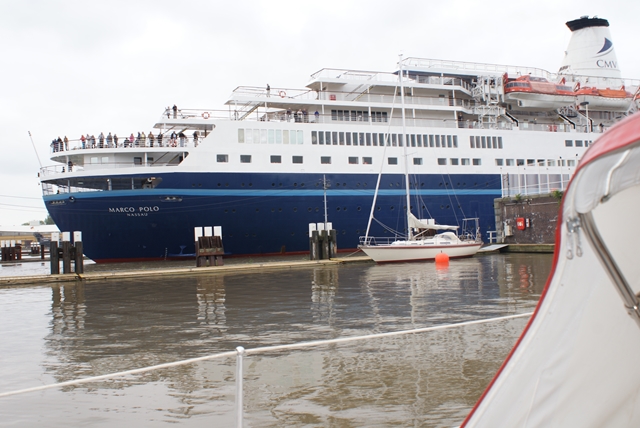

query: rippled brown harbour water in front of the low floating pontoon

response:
[0,254,552,427]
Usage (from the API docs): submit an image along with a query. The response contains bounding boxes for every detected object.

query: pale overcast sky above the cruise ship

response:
[0,0,640,226]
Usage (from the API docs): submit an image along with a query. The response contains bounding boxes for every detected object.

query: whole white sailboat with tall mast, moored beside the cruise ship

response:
[358,55,482,263]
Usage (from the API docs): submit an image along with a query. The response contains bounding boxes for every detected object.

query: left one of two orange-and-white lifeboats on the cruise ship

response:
[503,74,575,109]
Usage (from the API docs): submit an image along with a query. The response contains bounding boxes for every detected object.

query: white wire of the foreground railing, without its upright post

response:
[0,312,533,398]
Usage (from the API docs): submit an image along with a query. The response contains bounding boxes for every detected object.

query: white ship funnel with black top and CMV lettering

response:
[558,16,622,78]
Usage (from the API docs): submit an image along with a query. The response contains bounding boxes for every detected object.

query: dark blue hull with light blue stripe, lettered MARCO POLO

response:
[44,173,501,262]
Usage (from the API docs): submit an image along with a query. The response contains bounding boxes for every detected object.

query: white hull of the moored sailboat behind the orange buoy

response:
[360,241,482,263]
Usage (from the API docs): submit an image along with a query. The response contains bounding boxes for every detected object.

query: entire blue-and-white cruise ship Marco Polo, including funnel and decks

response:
[40,17,640,262]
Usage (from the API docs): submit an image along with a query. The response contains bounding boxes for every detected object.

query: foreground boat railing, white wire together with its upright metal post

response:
[0,312,533,427]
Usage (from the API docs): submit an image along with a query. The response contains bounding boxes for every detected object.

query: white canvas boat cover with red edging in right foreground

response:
[463,114,640,428]
